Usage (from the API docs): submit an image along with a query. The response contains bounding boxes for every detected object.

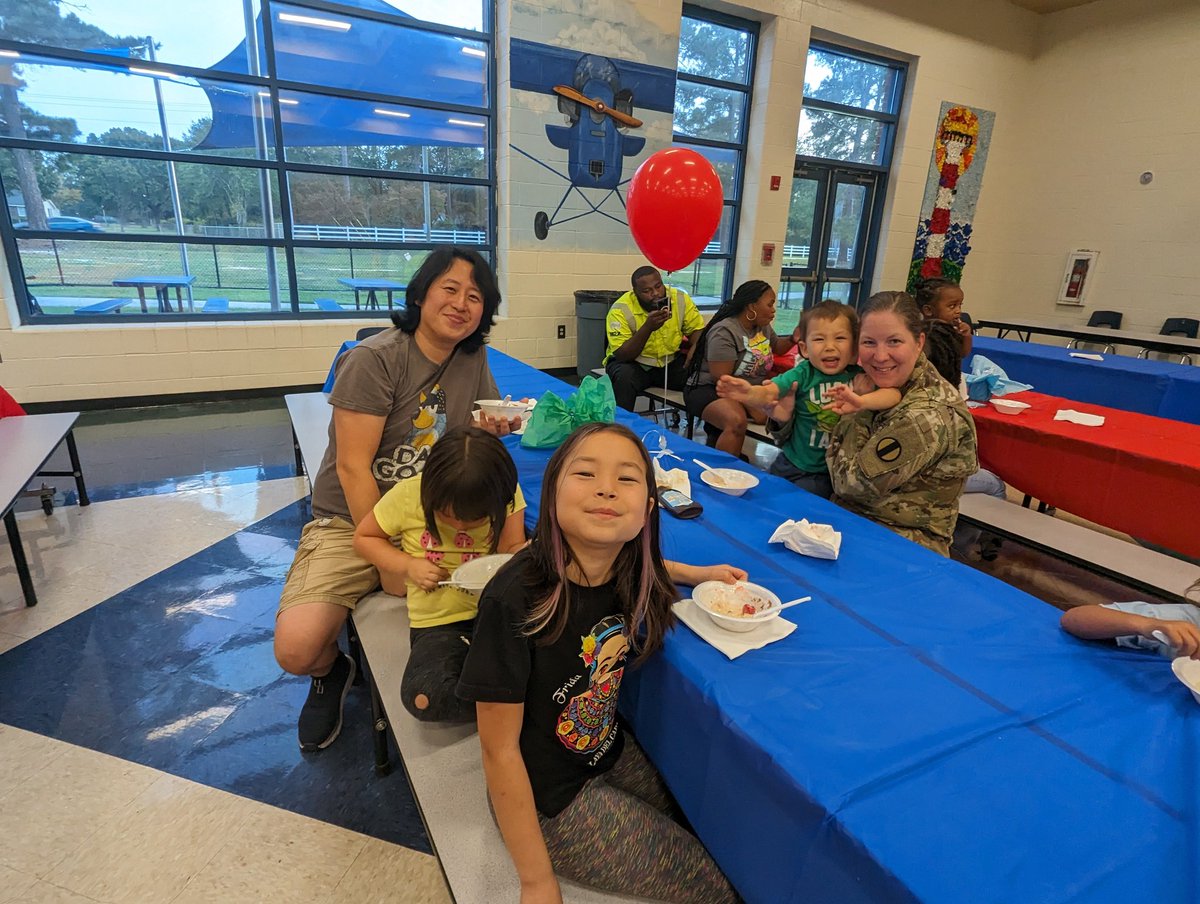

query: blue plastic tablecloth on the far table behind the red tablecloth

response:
[964,334,1200,424]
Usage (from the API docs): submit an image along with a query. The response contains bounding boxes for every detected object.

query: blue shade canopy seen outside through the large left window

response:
[198,0,488,150]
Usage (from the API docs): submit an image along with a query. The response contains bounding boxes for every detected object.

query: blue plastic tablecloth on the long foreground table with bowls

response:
[491,349,1200,904]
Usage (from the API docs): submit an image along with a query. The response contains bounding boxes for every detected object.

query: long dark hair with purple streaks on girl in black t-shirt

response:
[523,423,679,663]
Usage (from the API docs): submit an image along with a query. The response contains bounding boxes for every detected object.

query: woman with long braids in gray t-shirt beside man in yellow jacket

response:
[683,280,799,455]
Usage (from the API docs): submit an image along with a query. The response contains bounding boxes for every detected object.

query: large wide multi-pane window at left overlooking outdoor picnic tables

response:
[0,0,496,323]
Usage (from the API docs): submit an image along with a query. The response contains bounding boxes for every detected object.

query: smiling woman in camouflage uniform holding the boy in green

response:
[826,292,979,556]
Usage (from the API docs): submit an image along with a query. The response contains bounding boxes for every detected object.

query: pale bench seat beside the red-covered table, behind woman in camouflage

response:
[959,493,1200,601]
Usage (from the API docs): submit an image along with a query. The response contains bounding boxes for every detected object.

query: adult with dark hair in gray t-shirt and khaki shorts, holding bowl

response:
[275,247,520,750]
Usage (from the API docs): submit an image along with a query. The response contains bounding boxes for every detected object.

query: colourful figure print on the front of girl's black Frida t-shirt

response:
[557,615,629,754]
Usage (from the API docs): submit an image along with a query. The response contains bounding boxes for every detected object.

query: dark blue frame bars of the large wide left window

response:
[0,0,498,325]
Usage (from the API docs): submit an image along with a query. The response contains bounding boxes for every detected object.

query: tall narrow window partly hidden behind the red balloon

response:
[672,6,758,305]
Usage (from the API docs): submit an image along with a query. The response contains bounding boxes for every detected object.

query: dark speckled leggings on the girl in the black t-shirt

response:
[539,734,742,904]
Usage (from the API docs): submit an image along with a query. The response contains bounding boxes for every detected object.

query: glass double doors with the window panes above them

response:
[776,41,906,333]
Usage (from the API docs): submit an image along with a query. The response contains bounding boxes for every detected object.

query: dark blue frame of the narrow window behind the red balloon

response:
[671,4,760,310]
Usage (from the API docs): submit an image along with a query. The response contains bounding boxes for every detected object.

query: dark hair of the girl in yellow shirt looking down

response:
[421,427,517,552]
